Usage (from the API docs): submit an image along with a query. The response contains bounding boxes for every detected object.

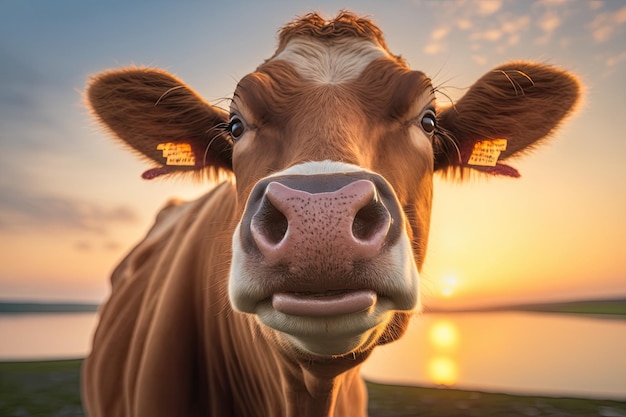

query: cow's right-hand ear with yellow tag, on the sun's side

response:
[435,62,581,177]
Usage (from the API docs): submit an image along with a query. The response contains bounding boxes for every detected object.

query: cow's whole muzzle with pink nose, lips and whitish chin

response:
[229,166,419,348]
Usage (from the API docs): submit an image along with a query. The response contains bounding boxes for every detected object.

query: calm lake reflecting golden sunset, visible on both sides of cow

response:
[0,312,626,400]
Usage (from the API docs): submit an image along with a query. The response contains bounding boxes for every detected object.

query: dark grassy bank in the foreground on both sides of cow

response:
[0,360,626,417]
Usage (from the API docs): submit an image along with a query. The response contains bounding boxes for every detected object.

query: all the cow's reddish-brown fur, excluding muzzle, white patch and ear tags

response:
[83,12,580,417]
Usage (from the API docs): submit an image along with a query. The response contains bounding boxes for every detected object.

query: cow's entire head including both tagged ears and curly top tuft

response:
[89,13,579,357]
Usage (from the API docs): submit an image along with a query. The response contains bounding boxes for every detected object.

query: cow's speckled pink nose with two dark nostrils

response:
[250,179,392,270]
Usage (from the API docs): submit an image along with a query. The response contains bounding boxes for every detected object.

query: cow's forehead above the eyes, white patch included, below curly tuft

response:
[231,34,433,123]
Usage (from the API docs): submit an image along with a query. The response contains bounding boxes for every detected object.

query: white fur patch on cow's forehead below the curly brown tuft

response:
[272,38,391,84]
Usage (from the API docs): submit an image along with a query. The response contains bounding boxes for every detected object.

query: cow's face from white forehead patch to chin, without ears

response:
[224,37,436,355]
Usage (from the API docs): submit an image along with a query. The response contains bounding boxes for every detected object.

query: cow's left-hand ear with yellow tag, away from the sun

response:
[87,68,232,179]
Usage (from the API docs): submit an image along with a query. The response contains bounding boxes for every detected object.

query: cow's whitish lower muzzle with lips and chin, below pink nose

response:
[229,229,419,358]
